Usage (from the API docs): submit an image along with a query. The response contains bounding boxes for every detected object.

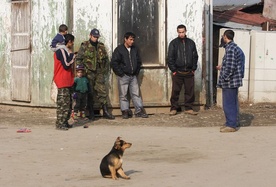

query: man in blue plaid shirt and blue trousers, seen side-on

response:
[217,30,245,132]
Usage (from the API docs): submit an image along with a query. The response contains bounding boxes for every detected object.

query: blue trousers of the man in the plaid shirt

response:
[222,88,239,128]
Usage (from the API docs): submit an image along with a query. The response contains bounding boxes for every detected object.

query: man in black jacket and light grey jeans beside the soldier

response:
[111,32,148,119]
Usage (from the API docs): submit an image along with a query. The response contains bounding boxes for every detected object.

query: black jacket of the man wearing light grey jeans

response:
[111,44,141,77]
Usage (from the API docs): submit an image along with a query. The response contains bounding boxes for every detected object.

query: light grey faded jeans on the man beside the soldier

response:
[117,75,143,114]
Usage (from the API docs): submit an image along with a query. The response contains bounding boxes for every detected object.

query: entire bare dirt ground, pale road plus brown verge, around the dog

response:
[0,104,276,187]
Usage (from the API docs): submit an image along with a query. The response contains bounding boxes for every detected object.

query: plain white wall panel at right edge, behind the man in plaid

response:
[249,31,276,103]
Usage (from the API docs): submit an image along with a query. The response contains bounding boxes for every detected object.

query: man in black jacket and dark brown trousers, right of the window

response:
[168,25,198,115]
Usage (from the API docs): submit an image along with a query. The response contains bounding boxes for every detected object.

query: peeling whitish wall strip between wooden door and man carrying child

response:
[31,0,68,106]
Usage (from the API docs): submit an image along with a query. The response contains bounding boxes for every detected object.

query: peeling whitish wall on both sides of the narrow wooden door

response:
[0,0,68,106]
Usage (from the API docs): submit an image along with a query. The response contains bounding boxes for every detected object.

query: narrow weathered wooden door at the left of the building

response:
[11,0,31,102]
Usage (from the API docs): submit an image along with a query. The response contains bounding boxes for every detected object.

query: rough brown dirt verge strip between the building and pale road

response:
[0,103,276,127]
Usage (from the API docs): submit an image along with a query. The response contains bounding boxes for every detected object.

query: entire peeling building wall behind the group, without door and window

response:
[0,0,204,107]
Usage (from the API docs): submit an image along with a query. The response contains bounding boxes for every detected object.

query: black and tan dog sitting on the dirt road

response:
[100,137,132,180]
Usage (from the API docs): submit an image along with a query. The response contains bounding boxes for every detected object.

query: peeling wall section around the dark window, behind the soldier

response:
[74,0,204,107]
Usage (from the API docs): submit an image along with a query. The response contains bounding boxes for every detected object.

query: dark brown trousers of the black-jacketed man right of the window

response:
[171,72,195,110]
